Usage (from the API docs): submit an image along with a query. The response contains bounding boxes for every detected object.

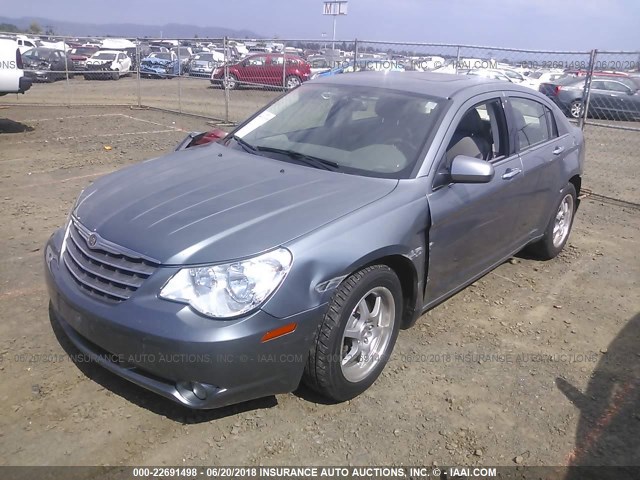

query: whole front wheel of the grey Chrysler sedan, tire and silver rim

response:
[303,265,402,402]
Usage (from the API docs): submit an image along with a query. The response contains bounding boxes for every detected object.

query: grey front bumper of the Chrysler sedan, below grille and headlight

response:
[45,230,326,409]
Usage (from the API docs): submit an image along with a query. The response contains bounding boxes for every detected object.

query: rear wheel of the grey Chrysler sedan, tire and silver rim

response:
[531,183,577,260]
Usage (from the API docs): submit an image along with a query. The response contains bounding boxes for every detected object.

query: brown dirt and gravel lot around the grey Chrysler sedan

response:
[0,97,640,465]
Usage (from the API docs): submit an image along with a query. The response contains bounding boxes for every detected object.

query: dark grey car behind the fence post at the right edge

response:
[540,75,640,121]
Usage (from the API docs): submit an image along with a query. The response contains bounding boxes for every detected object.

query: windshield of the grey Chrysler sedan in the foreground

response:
[228,84,444,178]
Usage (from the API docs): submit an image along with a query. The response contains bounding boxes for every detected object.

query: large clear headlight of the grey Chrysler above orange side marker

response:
[160,248,293,318]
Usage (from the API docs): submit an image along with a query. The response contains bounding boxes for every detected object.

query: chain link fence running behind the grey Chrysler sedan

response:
[1,37,640,193]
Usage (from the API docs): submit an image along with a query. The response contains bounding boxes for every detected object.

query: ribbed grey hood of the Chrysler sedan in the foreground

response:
[74,144,398,265]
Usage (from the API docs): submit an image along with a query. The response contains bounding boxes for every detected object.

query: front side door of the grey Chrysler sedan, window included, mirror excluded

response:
[425,93,527,303]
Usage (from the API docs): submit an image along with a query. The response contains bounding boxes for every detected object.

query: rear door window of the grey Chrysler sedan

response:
[511,98,551,151]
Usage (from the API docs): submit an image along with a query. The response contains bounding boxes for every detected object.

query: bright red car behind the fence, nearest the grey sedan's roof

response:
[211,53,311,90]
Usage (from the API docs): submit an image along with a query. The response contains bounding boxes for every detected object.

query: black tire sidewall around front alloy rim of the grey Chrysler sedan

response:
[322,268,402,400]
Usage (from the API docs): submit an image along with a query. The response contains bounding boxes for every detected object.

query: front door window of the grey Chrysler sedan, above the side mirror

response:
[445,98,508,168]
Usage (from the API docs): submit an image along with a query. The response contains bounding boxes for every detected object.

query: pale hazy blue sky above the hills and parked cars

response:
[2,0,640,51]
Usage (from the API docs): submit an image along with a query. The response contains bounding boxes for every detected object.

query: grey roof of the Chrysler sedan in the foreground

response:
[312,72,532,98]
